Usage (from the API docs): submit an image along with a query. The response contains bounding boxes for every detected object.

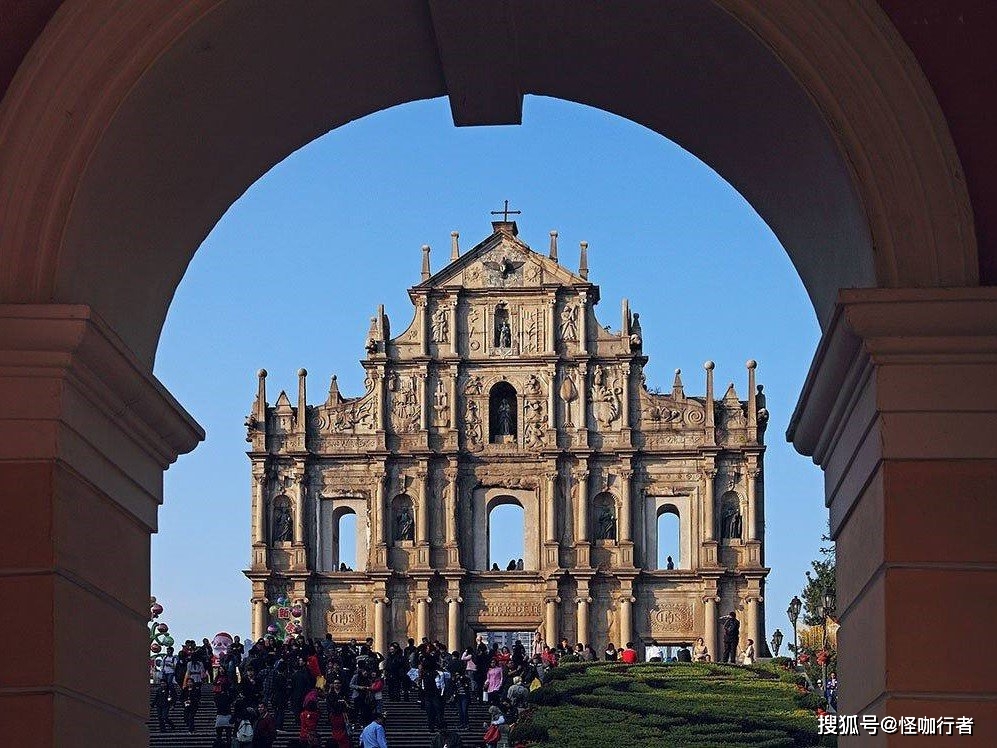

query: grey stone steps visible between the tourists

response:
[146,684,488,748]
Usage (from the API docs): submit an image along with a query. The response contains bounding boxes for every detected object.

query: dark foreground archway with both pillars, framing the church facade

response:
[0,0,997,746]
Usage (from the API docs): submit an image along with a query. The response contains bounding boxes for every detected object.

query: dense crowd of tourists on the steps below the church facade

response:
[152,614,764,748]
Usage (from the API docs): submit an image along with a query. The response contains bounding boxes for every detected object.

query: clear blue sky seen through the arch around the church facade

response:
[152,92,827,640]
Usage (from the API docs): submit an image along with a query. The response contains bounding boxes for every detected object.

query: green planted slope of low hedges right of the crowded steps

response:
[513,663,836,748]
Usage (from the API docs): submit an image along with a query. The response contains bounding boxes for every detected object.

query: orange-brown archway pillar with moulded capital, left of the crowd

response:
[0,304,204,747]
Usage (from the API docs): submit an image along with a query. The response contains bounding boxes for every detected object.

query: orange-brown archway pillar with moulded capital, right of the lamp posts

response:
[788,288,997,744]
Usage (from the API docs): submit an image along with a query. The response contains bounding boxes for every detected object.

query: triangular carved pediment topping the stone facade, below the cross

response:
[416,231,587,289]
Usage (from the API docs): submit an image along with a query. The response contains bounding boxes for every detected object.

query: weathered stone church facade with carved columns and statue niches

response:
[246,220,768,657]
